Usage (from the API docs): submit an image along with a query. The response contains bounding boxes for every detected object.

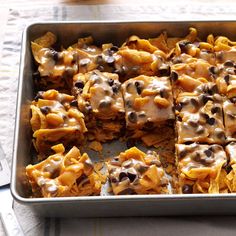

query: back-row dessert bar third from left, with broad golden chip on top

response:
[114,35,170,81]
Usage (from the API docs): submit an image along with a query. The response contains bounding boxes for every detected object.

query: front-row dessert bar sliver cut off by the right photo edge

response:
[225,142,236,193]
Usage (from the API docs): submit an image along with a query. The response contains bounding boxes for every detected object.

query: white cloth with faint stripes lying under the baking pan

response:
[0,3,236,236]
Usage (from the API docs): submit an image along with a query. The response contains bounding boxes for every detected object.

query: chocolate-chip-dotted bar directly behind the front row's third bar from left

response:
[176,83,225,144]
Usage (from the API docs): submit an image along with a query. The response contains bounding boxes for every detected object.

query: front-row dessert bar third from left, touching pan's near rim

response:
[176,143,227,193]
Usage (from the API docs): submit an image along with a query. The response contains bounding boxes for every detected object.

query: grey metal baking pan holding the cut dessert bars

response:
[11,21,236,217]
